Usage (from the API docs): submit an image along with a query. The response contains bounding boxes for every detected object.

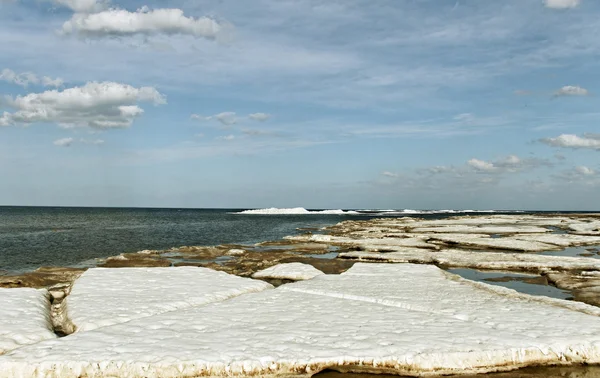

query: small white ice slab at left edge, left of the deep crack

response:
[0,289,56,354]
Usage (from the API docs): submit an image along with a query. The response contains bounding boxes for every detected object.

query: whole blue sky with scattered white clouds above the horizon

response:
[0,0,600,211]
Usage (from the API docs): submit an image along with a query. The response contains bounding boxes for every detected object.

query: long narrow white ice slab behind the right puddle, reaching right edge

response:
[338,249,600,273]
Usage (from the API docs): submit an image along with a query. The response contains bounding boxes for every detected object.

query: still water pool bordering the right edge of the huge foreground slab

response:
[448,269,572,299]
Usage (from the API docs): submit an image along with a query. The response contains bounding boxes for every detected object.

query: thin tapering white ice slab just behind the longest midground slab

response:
[432,235,561,252]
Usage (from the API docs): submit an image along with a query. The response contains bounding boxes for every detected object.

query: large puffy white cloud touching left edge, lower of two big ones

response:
[0,82,166,129]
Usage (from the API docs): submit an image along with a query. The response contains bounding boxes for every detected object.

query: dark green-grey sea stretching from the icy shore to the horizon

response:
[0,207,580,274]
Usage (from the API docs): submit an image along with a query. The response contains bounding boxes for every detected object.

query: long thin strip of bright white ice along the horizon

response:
[234,207,497,215]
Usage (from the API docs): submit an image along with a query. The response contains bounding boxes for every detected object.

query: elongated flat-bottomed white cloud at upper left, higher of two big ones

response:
[62,7,223,39]
